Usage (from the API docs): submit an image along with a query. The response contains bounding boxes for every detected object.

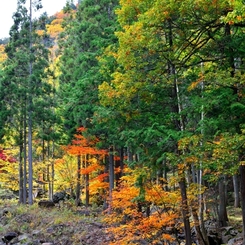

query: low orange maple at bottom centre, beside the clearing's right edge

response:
[105,168,180,245]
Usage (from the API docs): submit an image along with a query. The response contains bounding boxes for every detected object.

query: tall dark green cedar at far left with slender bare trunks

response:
[1,0,51,204]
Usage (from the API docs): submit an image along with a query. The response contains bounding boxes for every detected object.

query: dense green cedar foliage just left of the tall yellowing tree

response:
[59,0,118,142]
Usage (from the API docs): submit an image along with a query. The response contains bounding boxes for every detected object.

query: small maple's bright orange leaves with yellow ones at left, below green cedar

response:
[56,127,109,200]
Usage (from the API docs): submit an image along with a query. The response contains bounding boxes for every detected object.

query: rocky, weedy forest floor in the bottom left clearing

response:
[0,202,113,245]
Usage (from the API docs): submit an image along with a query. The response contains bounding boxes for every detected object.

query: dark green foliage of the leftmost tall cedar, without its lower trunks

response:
[1,0,53,138]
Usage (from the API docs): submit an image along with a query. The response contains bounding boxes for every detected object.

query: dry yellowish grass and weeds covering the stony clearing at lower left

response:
[0,201,107,245]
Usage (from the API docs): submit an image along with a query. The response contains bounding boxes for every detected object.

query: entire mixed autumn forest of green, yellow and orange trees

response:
[0,0,245,245]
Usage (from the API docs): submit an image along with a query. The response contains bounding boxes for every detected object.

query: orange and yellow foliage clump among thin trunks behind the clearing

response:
[58,127,109,201]
